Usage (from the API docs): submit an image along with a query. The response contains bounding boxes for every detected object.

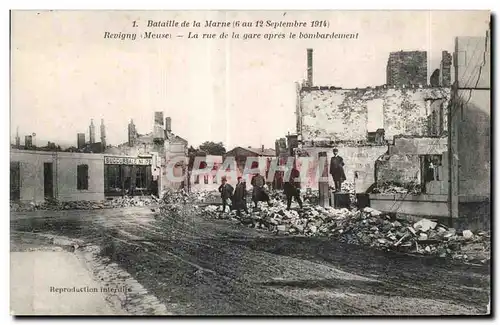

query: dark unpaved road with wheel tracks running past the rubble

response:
[11,208,490,315]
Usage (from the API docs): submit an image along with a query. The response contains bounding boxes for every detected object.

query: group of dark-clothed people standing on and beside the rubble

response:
[219,148,346,216]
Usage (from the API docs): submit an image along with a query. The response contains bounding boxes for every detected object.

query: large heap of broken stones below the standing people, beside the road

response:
[203,202,490,263]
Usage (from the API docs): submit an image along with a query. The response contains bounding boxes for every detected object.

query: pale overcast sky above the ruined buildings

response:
[11,11,489,150]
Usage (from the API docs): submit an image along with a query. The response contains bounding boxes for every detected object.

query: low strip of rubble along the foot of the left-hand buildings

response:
[10,196,160,212]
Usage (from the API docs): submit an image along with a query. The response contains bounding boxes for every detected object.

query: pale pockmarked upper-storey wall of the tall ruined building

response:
[298,86,450,141]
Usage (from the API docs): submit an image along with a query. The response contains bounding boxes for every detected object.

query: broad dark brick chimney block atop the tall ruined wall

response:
[386,51,427,87]
